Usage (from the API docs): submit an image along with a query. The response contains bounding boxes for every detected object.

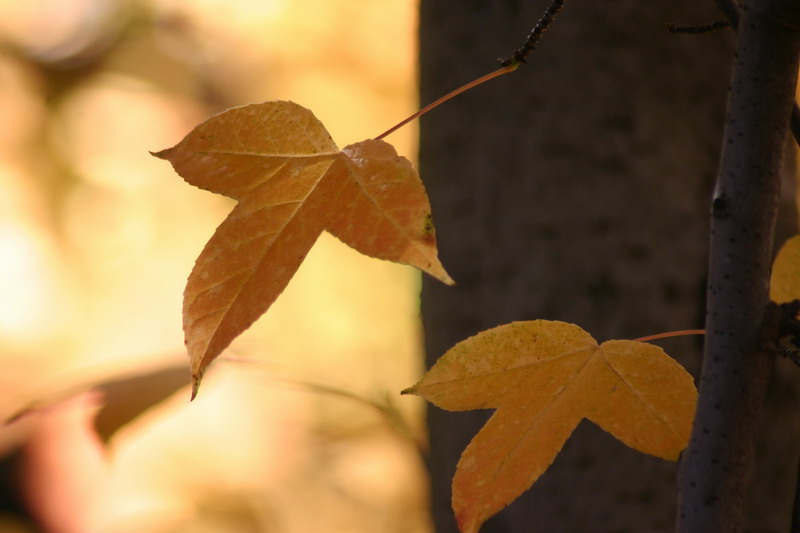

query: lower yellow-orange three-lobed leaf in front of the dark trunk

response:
[403,320,697,533]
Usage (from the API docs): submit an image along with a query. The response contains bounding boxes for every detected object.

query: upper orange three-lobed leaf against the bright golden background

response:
[154,102,452,396]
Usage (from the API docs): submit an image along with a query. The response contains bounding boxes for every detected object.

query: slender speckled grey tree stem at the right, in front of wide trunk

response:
[677,0,800,533]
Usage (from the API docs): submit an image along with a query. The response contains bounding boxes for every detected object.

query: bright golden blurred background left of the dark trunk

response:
[0,0,430,533]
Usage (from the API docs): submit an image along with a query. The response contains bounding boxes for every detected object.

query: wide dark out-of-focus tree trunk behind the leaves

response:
[420,0,795,533]
